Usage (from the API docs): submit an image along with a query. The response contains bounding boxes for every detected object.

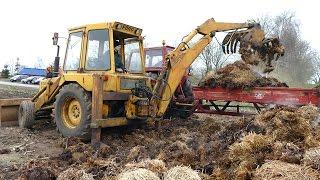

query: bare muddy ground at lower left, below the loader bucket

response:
[0,120,63,179]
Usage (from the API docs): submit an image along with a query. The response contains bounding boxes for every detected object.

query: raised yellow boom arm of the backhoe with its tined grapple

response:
[151,18,282,117]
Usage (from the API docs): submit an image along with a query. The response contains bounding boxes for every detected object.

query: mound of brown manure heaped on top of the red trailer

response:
[199,61,288,89]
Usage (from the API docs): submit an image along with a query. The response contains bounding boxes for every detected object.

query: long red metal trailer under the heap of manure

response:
[185,87,320,115]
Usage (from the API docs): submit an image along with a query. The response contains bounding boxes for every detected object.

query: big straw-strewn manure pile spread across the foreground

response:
[19,106,320,180]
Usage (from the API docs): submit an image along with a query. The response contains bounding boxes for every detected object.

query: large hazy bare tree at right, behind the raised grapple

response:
[257,12,314,86]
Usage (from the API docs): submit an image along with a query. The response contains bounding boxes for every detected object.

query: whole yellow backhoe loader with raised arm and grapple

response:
[0,19,282,143]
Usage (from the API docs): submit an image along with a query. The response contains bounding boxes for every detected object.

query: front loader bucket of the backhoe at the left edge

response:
[0,98,29,127]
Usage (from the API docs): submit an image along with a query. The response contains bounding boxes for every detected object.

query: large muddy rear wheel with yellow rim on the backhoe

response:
[54,83,91,140]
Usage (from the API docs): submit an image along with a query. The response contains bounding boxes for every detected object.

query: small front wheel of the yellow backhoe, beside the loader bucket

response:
[18,101,35,128]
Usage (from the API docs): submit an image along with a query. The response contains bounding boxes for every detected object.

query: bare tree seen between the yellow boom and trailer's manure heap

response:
[199,43,227,74]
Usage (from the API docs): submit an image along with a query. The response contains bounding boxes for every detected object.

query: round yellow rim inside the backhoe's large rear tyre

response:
[62,98,81,128]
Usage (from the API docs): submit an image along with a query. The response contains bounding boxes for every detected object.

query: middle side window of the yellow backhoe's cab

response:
[85,30,110,70]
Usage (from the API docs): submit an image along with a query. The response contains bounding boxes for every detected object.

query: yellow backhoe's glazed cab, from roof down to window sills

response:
[63,22,144,74]
